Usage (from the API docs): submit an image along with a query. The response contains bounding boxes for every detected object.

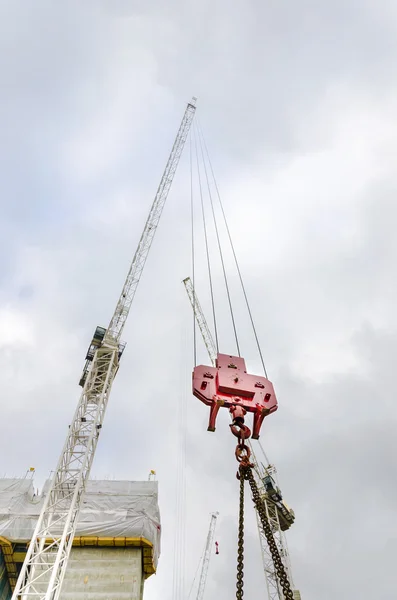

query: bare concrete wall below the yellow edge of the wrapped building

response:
[60,548,144,600]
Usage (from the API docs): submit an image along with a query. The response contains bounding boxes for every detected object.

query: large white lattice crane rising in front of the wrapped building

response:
[12,98,196,600]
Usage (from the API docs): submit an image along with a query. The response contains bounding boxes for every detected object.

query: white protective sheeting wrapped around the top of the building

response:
[0,479,161,565]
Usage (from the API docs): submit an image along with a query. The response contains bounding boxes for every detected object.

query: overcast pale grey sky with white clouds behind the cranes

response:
[0,0,397,600]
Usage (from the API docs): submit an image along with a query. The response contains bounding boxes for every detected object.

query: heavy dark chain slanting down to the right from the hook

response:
[240,463,294,600]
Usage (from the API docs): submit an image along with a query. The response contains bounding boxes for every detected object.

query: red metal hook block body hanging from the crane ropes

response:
[193,354,277,440]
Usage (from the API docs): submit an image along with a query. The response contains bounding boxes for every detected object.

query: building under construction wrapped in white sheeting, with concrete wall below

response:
[0,479,161,600]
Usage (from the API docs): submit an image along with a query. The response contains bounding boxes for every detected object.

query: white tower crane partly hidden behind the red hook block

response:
[183,277,301,600]
